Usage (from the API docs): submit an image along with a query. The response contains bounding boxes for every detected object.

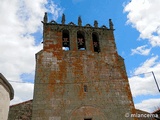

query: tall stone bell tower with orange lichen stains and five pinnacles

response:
[32,13,135,120]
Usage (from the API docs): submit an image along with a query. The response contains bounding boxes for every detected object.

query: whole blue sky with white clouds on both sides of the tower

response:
[0,0,160,112]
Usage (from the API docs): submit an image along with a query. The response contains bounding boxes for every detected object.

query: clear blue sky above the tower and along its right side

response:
[46,0,152,72]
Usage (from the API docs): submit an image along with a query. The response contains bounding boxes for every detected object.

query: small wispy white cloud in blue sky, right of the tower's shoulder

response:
[131,45,151,55]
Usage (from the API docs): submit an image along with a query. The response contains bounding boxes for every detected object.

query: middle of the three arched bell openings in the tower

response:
[77,31,86,50]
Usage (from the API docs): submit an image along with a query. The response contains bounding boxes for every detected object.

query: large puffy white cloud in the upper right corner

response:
[124,0,160,47]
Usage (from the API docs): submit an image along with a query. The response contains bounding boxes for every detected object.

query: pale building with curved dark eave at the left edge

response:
[0,73,14,120]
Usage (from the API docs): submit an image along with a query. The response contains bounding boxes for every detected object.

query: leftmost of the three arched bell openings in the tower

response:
[62,30,70,51]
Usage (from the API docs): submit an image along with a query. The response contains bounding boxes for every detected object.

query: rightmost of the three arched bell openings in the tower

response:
[92,33,100,53]
